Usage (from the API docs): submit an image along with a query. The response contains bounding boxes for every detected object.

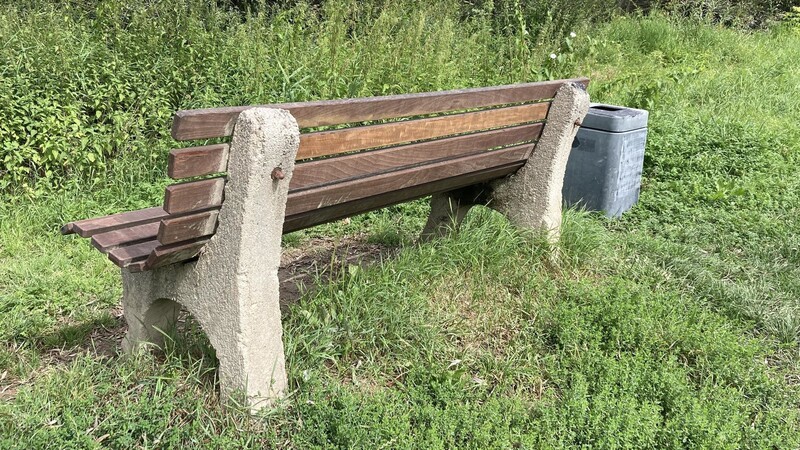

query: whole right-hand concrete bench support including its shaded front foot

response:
[422,83,589,241]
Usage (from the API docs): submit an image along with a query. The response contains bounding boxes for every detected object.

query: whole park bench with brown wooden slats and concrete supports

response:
[62,79,589,409]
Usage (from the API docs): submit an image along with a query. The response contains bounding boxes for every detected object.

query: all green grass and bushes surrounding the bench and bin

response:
[0,0,800,448]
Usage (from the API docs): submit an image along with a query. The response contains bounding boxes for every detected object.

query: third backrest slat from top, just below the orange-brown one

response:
[290,123,543,191]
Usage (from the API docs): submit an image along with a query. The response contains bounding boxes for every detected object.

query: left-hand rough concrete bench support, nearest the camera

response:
[123,108,300,410]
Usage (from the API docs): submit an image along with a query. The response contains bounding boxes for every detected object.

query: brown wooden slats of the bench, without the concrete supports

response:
[67,79,588,270]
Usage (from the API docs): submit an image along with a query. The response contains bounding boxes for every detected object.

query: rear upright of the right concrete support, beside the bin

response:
[489,84,589,241]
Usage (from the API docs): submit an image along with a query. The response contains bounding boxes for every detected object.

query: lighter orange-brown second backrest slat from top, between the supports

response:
[297,102,550,159]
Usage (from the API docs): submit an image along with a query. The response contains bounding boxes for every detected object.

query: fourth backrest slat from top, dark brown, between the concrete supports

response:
[286,144,533,216]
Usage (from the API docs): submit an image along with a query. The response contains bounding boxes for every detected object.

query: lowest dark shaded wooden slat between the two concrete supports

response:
[283,161,525,233]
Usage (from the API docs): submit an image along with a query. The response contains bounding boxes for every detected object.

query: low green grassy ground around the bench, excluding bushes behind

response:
[0,5,800,448]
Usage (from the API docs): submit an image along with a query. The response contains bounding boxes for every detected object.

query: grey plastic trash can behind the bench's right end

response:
[562,103,648,217]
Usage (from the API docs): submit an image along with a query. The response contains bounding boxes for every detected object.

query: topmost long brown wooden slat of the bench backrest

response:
[172,78,589,141]
